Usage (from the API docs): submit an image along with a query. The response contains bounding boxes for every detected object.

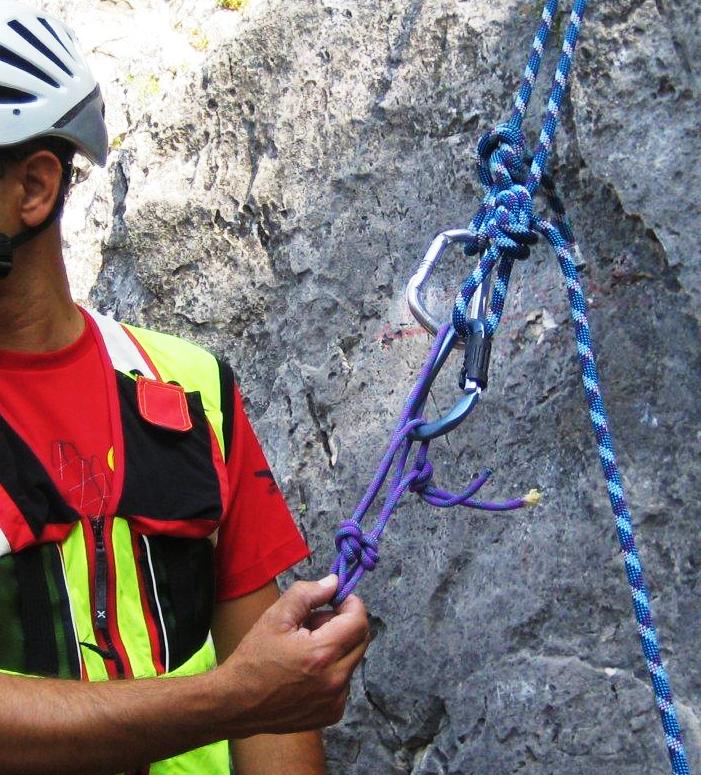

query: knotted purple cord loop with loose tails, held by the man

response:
[331,324,537,606]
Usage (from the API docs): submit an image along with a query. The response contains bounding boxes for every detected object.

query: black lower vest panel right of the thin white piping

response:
[145,536,215,670]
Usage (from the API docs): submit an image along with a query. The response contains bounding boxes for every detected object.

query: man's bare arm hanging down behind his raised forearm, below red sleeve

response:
[212,581,326,775]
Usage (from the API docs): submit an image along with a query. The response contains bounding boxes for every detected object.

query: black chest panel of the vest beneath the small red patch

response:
[116,372,222,522]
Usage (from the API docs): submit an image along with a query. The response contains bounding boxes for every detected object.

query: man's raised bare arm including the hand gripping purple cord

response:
[0,577,369,775]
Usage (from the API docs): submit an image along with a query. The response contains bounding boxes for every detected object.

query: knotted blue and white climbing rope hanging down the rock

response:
[446,0,690,775]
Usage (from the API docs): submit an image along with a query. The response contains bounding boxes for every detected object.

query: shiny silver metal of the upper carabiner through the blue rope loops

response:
[405,229,490,350]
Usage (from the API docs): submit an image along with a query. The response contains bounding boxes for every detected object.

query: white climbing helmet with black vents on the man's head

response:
[0,0,108,167]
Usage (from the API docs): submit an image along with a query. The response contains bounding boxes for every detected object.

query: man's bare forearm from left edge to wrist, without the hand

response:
[0,656,223,775]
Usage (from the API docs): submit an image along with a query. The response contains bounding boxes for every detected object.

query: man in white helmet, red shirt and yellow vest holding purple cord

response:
[0,2,368,775]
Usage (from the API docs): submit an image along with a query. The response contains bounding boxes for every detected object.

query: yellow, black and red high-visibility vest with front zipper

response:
[0,312,233,775]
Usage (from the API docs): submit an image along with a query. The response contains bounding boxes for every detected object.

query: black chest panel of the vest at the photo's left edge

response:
[0,417,80,538]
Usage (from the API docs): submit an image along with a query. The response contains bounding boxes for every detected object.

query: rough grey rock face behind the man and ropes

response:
[46,0,701,775]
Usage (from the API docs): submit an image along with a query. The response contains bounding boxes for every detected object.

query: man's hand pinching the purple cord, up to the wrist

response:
[212,576,370,738]
